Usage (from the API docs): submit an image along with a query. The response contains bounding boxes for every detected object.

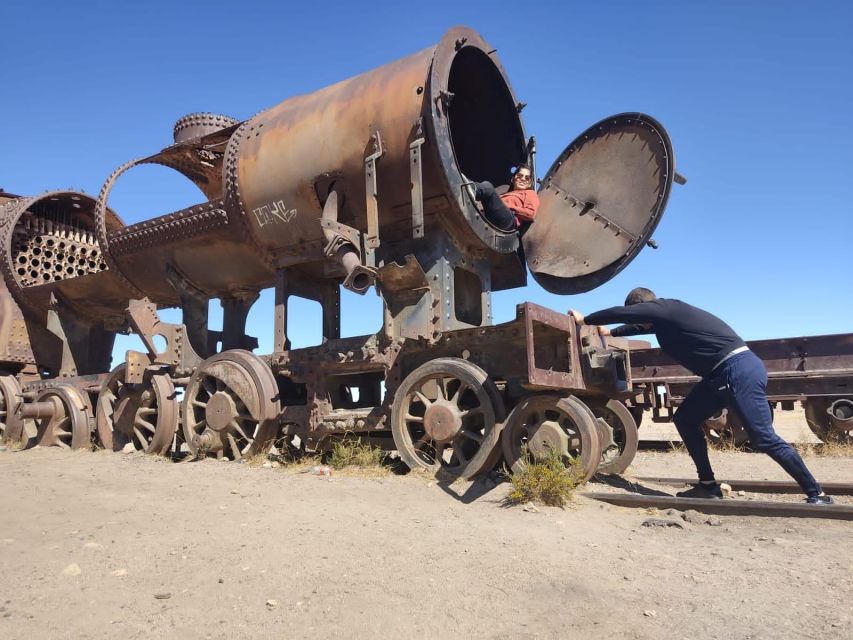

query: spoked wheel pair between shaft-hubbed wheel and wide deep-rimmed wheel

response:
[95,364,179,455]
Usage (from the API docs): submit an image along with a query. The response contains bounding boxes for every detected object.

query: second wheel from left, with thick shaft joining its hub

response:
[35,384,92,449]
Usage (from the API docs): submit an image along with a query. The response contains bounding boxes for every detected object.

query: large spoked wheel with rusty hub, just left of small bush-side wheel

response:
[391,358,504,478]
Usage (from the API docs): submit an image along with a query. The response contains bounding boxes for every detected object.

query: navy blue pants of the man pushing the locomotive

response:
[673,351,821,496]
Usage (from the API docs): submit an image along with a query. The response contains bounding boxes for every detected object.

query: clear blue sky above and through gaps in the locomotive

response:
[0,0,853,352]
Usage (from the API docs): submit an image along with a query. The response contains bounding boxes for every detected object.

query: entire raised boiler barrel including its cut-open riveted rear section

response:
[91,27,526,305]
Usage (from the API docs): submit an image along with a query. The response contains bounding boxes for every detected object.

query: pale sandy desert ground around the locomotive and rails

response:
[0,408,853,640]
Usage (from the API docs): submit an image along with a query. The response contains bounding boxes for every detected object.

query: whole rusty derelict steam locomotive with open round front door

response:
[0,27,680,477]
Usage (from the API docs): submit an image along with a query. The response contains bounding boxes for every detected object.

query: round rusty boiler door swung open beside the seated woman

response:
[522,113,675,294]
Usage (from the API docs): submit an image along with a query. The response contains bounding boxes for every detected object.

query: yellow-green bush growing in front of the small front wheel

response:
[505,450,583,507]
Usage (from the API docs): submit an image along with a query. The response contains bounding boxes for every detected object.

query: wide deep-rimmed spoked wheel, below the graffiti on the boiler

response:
[183,349,281,460]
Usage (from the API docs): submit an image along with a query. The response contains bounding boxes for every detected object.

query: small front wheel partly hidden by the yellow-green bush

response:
[501,394,601,482]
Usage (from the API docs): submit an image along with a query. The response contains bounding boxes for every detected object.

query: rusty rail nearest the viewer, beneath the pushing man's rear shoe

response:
[583,493,853,520]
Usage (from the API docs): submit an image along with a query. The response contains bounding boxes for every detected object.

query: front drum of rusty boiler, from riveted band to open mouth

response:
[231,27,525,261]
